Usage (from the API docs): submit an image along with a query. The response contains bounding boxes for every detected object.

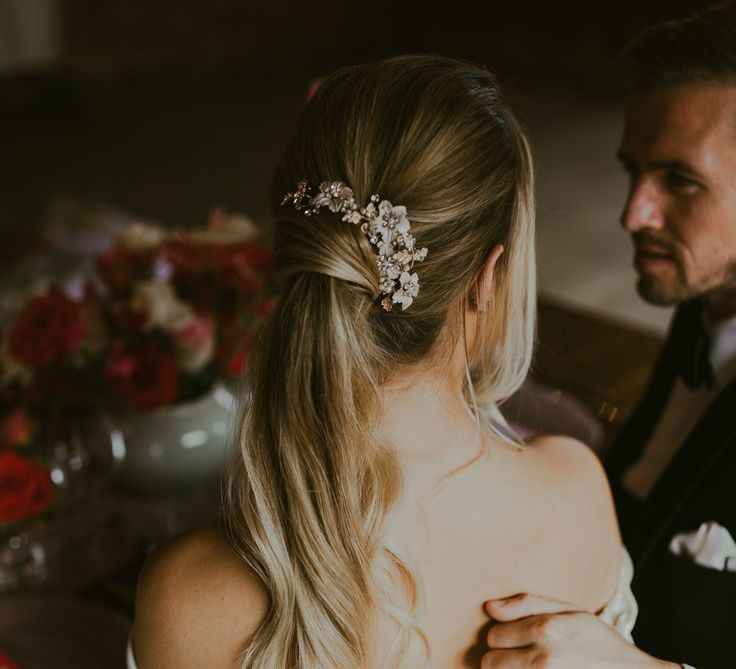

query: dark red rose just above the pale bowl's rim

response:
[105,340,179,411]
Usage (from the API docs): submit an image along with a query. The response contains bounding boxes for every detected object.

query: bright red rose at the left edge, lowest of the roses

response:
[0,449,54,523]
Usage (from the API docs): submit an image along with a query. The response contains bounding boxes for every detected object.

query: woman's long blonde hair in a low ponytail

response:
[225,55,536,669]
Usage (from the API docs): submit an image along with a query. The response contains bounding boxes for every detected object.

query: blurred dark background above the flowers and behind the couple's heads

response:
[0,0,712,333]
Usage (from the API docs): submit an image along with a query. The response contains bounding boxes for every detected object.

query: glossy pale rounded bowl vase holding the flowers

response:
[110,383,237,495]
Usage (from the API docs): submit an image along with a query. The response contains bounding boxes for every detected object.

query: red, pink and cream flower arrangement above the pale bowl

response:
[0,209,273,523]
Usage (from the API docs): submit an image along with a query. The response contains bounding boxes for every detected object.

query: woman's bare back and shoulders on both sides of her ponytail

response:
[134,430,620,669]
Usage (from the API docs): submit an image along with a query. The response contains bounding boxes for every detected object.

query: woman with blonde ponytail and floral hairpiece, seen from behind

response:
[129,56,635,669]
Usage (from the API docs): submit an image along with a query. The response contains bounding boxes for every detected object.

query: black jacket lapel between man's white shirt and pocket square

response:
[637,381,736,568]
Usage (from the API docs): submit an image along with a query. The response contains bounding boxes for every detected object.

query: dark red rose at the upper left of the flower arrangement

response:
[8,286,86,367]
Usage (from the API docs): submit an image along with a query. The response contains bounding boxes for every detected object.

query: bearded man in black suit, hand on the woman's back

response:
[482,3,736,669]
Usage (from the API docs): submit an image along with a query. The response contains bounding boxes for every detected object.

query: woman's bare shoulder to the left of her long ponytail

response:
[133,527,268,669]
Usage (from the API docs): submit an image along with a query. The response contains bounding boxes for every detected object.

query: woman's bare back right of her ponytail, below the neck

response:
[396,437,621,669]
